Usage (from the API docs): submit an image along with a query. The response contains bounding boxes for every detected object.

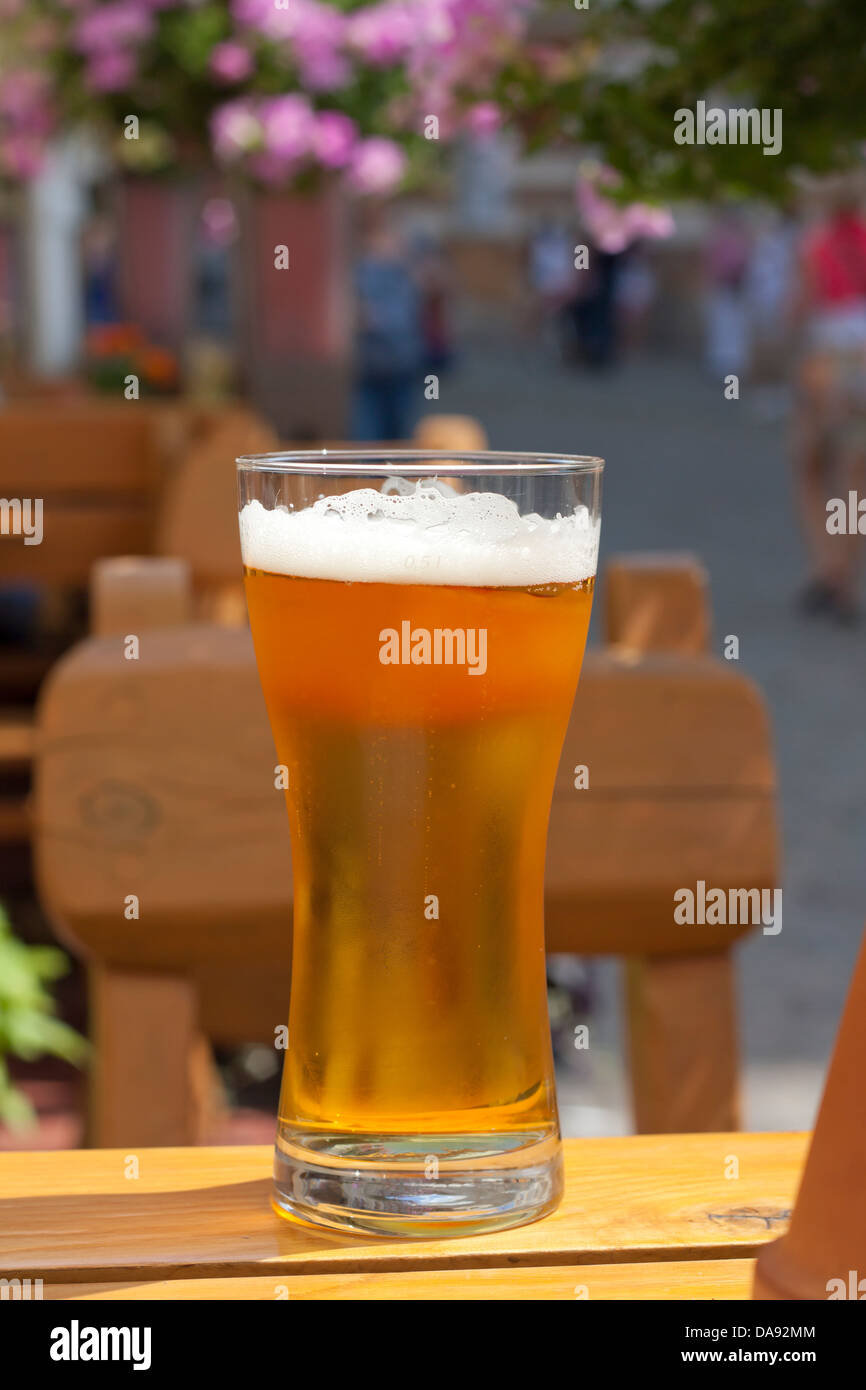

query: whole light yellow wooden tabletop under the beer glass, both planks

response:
[0,1134,808,1300]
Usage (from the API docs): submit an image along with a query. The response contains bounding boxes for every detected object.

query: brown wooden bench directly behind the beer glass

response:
[35,560,777,1145]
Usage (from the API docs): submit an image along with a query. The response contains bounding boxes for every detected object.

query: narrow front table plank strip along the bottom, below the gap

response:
[43,1259,755,1302]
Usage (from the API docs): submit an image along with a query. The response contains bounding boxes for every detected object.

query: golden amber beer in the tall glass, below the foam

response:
[237,450,603,1229]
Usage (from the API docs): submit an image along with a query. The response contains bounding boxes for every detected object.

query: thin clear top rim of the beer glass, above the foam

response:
[235,449,605,478]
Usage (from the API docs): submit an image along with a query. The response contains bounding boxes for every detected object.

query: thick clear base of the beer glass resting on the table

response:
[274,1126,563,1240]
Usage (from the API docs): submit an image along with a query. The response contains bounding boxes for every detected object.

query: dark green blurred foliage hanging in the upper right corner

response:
[500,0,866,197]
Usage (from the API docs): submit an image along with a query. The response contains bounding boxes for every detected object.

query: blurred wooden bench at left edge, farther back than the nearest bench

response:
[0,398,271,844]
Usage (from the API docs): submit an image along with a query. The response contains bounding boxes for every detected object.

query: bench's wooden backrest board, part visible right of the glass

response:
[545,652,778,955]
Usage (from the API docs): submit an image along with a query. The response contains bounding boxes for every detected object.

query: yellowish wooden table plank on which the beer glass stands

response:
[0,1134,806,1283]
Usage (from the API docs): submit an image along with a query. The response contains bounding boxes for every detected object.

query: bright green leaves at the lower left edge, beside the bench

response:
[0,908,88,1127]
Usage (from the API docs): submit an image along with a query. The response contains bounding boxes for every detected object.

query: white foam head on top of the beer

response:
[240,478,599,588]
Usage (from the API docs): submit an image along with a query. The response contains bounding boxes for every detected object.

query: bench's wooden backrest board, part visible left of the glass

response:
[33,624,291,973]
